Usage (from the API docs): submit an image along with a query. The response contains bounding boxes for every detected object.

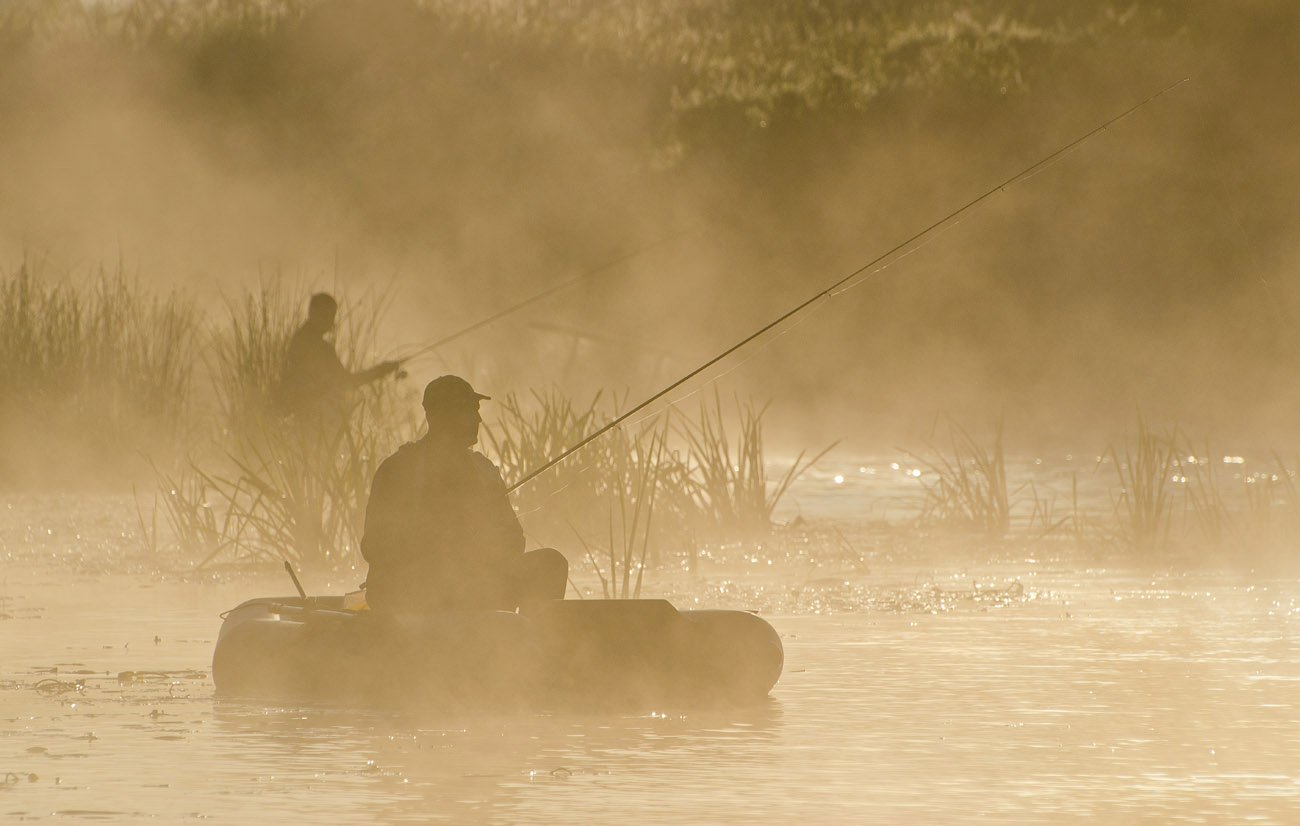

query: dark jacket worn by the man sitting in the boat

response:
[361,437,524,611]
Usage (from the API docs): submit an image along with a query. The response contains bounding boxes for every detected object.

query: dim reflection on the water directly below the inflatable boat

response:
[213,701,781,822]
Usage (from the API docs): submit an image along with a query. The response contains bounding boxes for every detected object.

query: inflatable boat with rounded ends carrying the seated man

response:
[212,597,784,709]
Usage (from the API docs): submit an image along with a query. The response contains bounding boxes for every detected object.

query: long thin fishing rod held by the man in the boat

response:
[507,78,1191,493]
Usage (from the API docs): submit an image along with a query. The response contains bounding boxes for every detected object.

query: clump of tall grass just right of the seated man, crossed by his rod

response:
[485,390,833,585]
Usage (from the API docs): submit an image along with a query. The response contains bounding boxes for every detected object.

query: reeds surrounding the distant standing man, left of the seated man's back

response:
[148,278,419,567]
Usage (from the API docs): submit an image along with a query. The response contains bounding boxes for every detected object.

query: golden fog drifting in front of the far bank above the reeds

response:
[0,3,1297,446]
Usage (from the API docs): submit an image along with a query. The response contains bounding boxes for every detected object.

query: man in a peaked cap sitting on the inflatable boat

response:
[361,376,568,613]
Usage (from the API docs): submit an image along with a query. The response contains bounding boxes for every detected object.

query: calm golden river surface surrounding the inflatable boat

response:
[0,494,1300,825]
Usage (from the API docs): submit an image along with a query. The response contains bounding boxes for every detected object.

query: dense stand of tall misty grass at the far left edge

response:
[0,263,200,476]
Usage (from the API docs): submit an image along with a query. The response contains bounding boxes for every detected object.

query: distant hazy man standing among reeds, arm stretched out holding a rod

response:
[276,293,400,421]
